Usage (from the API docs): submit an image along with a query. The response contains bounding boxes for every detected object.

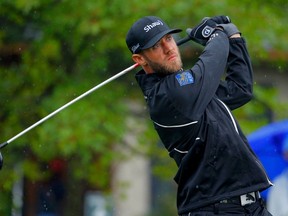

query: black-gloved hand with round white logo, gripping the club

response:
[186,16,231,46]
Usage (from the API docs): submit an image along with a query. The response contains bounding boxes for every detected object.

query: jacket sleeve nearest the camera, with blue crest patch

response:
[167,31,229,120]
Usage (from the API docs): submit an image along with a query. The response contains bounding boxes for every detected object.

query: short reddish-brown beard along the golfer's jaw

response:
[143,51,183,75]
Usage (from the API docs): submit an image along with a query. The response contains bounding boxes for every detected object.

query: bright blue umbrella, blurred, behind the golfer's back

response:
[247,120,288,198]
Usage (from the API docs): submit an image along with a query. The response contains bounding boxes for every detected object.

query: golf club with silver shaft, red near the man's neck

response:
[0,34,191,169]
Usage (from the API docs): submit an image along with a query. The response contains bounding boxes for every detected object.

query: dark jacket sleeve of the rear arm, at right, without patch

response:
[216,38,253,110]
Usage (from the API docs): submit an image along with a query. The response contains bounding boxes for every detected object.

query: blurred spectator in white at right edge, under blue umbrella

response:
[267,136,288,216]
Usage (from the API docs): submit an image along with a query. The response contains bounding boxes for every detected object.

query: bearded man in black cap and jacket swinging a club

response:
[126,16,271,216]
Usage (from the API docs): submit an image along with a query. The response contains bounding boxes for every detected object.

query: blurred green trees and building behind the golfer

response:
[0,0,288,216]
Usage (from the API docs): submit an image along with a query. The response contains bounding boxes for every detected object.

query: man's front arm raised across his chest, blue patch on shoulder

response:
[148,21,229,125]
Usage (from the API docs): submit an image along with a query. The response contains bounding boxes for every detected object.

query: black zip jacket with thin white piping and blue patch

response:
[136,31,271,214]
